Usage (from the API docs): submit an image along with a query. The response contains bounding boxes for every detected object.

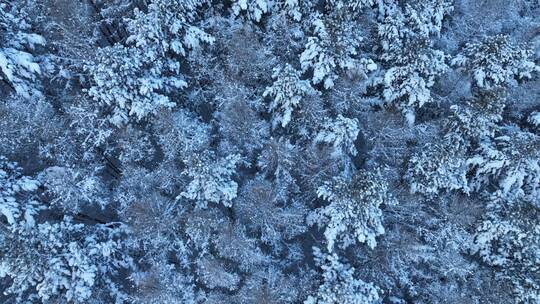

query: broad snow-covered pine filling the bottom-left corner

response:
[0,218,132,303]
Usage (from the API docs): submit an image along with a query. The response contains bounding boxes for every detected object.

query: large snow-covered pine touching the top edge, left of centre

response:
[86,0,214,126]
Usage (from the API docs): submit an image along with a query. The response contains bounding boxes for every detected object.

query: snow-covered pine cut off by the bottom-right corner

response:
[469,198,540,303]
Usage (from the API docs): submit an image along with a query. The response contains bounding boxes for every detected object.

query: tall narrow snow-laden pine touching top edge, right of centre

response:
[375,0,453,125]
